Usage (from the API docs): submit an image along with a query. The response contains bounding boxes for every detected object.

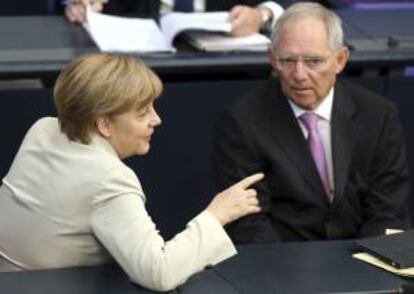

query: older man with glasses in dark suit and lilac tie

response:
[213,3,410,243]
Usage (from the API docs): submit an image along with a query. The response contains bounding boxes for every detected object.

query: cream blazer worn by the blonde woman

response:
[0,118,236,290]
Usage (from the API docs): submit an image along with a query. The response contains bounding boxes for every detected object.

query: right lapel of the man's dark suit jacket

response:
[331,82,357,203]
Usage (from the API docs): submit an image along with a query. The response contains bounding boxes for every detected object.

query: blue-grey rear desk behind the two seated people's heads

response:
[0,9,414,79]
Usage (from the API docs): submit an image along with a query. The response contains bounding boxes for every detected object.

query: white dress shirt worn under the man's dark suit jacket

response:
[288,88,334,199]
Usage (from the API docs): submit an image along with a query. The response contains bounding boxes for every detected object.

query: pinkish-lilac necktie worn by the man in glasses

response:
[299,112,331,199]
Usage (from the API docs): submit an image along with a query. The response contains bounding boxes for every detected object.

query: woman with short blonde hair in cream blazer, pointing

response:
[0,54,263,291]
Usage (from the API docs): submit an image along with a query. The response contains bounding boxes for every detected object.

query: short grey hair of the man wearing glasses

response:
[271,2,344,49]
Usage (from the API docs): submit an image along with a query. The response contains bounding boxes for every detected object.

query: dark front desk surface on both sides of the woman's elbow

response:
[0,241,408,294]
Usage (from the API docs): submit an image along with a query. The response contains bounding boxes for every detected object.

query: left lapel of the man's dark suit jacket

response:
[264,81,327,200]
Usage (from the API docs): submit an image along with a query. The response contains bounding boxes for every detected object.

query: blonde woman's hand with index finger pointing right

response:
[207,173,264,226]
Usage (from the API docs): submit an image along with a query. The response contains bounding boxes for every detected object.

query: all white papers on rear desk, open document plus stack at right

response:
[84,10,270,52]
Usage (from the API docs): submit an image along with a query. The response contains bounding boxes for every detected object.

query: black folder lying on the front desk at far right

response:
[355,230,414,269]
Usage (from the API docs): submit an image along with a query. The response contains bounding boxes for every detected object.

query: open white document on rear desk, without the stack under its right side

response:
[85,10,231,52]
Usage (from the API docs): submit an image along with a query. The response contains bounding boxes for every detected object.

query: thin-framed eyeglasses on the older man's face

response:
[276,51,336,70]
